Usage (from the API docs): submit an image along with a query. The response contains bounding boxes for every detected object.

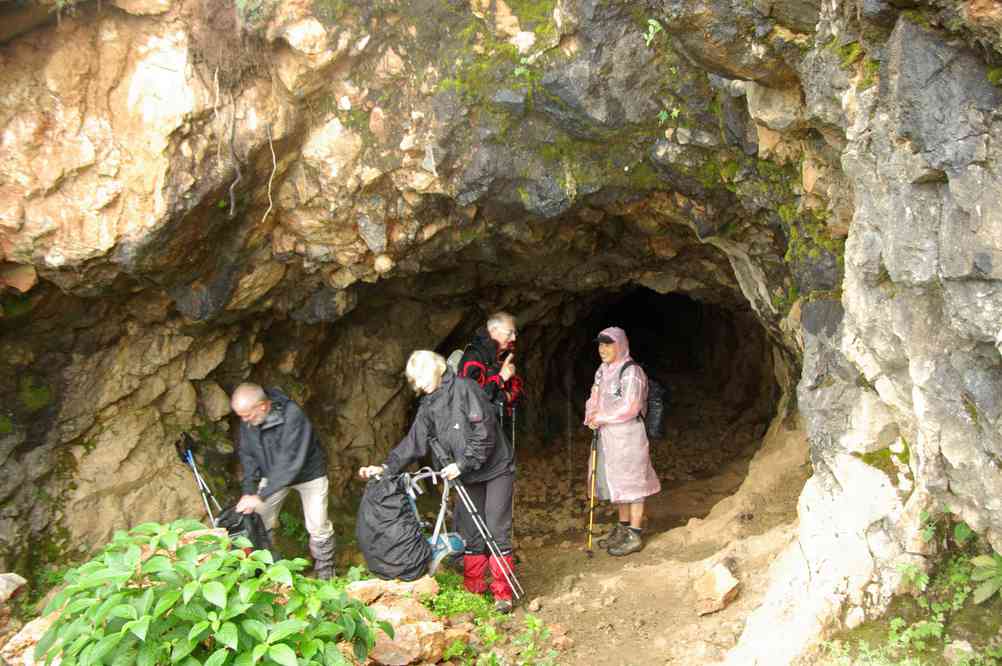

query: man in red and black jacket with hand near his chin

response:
[458,312,522,416]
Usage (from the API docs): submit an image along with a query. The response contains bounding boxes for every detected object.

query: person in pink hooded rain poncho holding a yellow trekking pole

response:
[584,326,661,555]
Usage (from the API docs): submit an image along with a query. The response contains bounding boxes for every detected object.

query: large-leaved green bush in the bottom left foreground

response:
[35,520,393,666]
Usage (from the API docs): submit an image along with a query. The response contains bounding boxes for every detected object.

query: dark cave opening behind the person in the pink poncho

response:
[422,284,782,545]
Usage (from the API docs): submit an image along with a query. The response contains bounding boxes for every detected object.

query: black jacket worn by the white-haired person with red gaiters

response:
[386,370,514,484]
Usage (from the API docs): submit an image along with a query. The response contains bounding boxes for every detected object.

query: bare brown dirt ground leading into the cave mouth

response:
[496,378,810,666]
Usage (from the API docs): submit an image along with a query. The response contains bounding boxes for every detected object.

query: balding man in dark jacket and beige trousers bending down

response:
[230,384,335,580]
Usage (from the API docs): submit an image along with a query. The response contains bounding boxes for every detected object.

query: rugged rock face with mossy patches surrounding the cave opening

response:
[0,0,1002,664]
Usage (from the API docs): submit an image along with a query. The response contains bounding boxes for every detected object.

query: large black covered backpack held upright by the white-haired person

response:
[355,476,432,581]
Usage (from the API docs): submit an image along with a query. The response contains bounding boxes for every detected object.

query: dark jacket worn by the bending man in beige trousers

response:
[240,389,327,500]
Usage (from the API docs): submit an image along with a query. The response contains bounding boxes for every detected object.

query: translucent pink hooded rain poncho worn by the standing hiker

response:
[584,326,661,503]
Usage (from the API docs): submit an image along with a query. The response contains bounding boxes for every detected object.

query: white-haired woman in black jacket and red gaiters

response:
[359,351,515,612]
